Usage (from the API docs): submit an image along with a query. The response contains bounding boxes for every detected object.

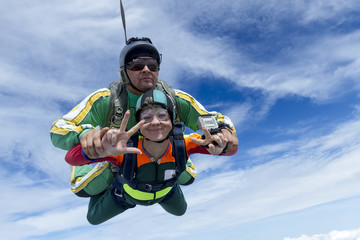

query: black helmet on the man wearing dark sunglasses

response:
[119,37,161,84]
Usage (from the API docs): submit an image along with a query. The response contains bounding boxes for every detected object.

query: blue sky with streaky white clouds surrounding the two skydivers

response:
[0,0,360,240]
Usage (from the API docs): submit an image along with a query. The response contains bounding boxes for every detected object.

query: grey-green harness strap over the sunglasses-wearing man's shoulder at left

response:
[107,80,128,128]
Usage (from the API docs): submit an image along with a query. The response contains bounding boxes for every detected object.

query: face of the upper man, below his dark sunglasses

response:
[126,57,159,94]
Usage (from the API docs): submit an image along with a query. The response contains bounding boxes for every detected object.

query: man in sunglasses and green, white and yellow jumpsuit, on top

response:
[50,38,238,195]
